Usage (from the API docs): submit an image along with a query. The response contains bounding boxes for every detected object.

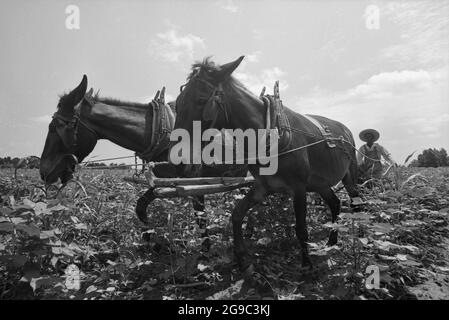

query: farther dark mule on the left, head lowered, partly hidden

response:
[40,76,247,229]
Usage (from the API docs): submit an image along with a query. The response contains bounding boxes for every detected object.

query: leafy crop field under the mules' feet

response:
[0,167,449,300]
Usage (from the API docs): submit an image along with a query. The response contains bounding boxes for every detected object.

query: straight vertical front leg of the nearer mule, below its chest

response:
[293,185,312,268]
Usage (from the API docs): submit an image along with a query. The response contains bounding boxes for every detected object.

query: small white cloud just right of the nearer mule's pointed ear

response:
[235,67,288,95]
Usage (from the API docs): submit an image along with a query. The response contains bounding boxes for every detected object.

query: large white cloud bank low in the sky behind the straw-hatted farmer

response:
[294,68,449,161]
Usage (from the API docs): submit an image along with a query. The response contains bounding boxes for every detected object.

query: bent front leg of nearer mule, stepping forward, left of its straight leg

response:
[232,184,266,271]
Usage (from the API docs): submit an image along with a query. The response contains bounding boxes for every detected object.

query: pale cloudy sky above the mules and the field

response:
[0,0,449,162]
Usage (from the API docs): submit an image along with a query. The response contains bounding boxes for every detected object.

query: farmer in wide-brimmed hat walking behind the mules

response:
[357,129,395,179]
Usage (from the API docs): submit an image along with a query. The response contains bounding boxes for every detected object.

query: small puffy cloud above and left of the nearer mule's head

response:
[149,26,206,62]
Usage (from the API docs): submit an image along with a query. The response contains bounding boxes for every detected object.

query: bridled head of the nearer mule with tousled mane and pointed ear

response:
[169,56,244,176]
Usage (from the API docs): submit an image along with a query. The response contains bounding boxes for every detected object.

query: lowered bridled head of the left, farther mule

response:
[40,75,97,184]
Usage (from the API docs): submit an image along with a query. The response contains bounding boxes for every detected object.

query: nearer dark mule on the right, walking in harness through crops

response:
[175,57,358,271]
